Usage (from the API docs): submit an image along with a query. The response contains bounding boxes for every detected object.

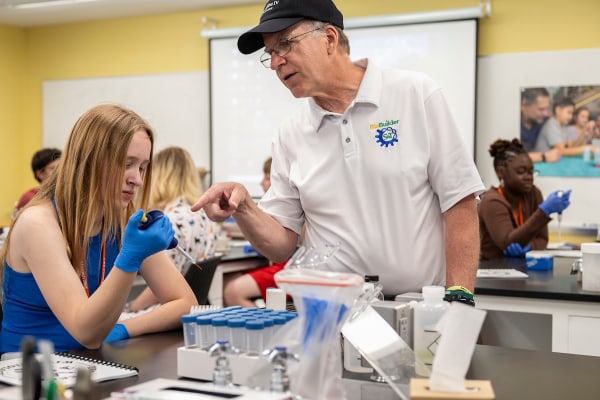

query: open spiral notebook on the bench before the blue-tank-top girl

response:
[0,352,139,387]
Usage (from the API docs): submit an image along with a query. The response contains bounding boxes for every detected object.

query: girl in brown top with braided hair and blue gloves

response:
[479,139,571,260]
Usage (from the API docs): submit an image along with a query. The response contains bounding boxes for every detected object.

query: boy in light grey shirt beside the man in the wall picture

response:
[533,97,591,156]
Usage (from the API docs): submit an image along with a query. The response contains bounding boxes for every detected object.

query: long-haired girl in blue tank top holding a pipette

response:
[0,104,196,353]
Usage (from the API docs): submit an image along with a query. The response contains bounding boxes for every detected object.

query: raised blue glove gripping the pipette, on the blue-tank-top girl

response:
[115,210,175,272]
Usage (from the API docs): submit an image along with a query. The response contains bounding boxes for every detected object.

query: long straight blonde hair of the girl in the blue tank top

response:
[0,104,154,272]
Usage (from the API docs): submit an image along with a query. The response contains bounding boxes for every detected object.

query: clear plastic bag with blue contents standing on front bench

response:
[274,268,363,400]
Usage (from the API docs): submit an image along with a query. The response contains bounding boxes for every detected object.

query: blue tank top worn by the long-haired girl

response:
[0,235,119,353]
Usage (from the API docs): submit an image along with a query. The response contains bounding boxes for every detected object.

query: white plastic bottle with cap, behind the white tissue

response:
[413,286,450,376]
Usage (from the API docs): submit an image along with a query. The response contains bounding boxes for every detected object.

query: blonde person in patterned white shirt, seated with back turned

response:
[123,147,218,312]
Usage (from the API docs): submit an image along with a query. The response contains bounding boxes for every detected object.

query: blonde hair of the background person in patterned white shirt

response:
[150,146,202,210]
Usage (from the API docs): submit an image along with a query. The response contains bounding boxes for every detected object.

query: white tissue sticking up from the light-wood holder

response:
[429,302,486,392]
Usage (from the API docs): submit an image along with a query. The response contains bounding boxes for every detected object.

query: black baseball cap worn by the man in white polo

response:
[238,0,344,54]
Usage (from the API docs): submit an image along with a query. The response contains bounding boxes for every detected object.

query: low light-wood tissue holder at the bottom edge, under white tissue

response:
[410,378,496,400]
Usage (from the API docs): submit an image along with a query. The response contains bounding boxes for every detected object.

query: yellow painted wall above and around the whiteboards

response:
[0,0,600,224]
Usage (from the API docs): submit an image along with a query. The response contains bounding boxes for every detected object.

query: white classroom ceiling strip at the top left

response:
[0,0,264,27]
